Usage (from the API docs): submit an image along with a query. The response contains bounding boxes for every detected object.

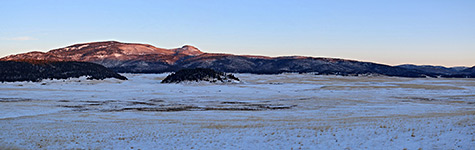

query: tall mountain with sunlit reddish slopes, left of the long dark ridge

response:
[0,41,203,72]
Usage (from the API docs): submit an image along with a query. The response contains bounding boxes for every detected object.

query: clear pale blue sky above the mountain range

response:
[0,0,475,67]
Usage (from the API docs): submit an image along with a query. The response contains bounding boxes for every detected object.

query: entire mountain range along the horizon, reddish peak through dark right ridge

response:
[0,41,474,77]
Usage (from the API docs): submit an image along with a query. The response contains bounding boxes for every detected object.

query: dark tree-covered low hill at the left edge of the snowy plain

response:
[0,60,127,82]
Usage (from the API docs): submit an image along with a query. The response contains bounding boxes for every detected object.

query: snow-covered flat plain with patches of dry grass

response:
[0,74,475,149]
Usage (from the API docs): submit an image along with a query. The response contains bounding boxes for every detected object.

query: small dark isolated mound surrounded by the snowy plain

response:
[162,68,239,83]
